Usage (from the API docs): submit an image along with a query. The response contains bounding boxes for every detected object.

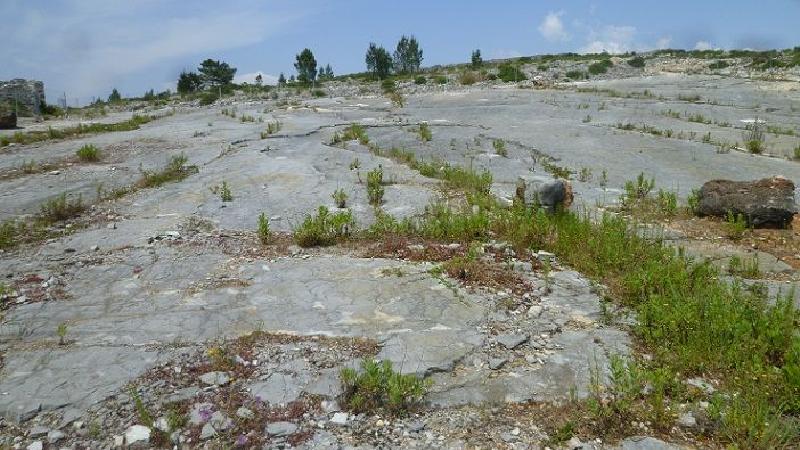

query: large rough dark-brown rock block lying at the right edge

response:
[697,177,796,228]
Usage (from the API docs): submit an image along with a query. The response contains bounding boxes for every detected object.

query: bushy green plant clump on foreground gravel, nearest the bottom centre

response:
[340,360,428,416]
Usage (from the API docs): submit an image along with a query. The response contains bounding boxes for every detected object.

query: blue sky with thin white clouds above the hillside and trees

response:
[0,0,800,103]
